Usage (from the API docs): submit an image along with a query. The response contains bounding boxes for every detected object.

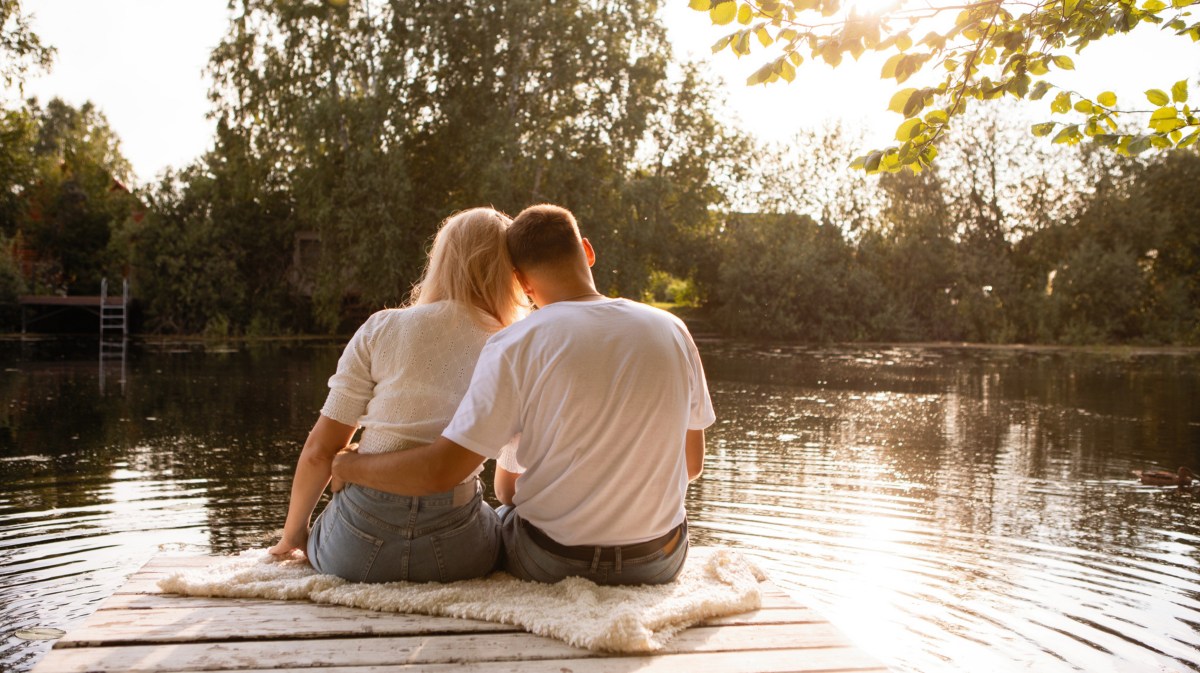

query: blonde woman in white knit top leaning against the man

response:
[270,208,526,582]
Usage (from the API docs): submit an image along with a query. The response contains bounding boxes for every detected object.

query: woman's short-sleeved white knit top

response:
[320,301,500,453]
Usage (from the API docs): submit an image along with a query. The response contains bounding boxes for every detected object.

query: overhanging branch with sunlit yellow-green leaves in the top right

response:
[690,0,1200,173]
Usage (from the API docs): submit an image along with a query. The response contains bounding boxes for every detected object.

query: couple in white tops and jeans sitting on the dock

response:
[271,205,714,584]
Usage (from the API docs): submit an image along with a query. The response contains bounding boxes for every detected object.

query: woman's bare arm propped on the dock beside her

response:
[270,416,356,557]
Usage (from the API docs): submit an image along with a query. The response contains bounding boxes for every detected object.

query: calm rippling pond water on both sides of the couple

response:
[0,341,1200,673]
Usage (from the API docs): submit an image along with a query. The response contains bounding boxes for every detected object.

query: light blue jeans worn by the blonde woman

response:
[308,483,500,582]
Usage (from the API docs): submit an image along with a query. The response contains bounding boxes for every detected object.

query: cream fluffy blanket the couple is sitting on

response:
[158,549,766,653]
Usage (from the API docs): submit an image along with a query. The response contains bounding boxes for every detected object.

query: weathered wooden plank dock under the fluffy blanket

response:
[34,555,887,673]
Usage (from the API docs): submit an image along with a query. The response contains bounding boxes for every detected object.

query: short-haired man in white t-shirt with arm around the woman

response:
[334,205,714,584]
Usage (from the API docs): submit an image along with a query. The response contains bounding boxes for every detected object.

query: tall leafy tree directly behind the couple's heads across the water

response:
[199,0,700,329]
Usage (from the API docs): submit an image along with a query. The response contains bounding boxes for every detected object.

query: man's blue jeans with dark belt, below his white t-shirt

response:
[498,505,688,584]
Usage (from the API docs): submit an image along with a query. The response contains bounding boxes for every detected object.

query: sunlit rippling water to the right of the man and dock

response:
[692,347,1200,672]
